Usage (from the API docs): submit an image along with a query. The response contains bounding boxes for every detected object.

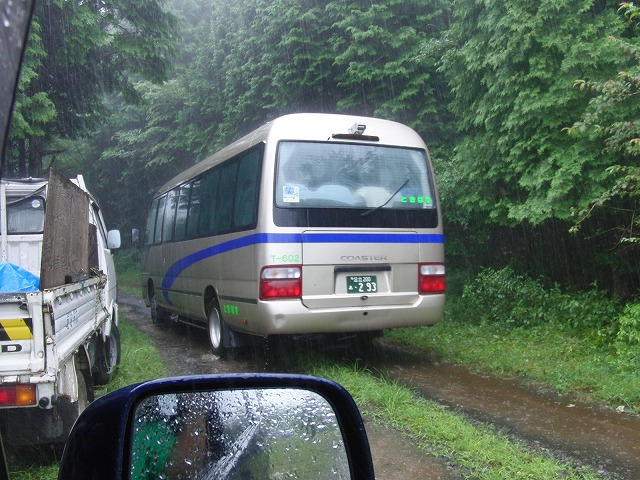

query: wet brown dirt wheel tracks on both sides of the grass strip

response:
[120,295,640,480]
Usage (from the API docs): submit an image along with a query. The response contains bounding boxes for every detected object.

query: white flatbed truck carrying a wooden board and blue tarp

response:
[0,170,120,445]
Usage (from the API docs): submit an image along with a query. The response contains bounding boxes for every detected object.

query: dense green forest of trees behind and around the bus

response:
[3,0,640,298]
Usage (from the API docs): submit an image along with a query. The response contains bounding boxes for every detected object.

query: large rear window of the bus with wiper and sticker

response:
[275,142,436,210]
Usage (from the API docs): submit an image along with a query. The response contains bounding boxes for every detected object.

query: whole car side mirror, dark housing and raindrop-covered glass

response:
[58,374,374,480]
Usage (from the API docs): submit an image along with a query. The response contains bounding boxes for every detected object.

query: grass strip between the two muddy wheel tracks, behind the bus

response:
[311,366,599,480]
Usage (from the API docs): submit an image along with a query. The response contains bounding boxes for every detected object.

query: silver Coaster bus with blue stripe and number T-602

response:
[142,114,445,342]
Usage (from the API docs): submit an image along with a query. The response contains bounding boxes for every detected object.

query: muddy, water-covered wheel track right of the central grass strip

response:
[369,348,640,479]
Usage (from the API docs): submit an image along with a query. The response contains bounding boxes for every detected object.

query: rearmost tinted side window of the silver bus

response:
[233,150,260,228]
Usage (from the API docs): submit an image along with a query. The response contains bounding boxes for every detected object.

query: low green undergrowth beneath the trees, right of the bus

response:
[446,267,640,378]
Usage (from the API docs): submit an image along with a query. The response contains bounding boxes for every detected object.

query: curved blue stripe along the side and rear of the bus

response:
[162,233,444,304]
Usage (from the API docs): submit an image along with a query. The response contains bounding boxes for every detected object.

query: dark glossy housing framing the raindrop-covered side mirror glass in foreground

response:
[58,374,375,480]
